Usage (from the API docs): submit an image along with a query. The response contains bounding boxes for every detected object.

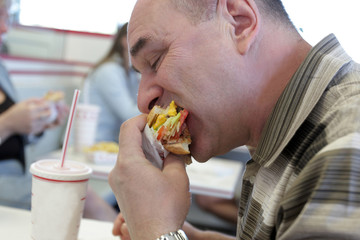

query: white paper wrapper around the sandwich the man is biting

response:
[142,124,169,169]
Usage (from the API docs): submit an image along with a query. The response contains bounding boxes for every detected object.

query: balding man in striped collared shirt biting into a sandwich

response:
[110,0,360,240]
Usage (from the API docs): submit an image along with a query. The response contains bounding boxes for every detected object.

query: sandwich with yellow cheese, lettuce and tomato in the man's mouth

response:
[143,101,191,168]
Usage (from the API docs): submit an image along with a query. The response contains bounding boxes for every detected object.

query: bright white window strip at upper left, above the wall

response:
[18,0,136,34]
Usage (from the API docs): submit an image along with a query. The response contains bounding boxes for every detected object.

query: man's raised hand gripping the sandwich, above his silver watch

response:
[109,115,190,240]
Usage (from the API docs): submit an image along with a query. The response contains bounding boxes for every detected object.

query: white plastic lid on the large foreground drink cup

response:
[30,159,92,181]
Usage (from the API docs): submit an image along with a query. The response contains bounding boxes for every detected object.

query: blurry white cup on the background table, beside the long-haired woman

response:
[74,104,100,152]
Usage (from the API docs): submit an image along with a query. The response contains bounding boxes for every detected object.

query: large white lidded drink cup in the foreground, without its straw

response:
[30,159,92,240]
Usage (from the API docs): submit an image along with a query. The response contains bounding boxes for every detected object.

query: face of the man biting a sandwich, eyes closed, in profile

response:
[128,0,250,161]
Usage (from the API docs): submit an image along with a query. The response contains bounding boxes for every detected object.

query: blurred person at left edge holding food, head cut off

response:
[0,0,69,209]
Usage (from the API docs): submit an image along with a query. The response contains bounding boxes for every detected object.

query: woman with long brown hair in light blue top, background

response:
[82,23,140,142]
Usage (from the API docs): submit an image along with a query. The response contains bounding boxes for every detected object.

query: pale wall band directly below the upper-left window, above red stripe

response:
[5,25,112,63]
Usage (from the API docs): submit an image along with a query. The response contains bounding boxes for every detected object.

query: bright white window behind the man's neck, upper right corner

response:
[283,0,360,62]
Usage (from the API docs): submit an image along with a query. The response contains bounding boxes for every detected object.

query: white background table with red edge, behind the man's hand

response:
[44,147,244,199]
